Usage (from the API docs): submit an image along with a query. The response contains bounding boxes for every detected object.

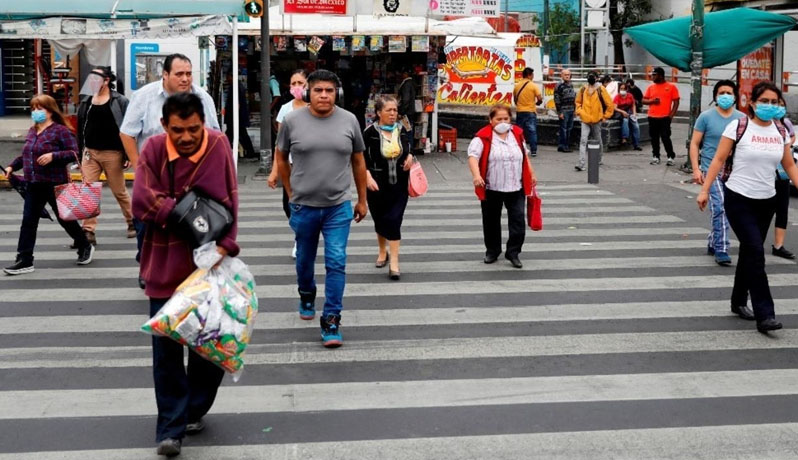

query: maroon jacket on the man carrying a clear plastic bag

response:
[133,129,239,298]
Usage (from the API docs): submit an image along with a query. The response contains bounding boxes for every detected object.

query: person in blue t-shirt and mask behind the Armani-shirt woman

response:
[690,80,745,266]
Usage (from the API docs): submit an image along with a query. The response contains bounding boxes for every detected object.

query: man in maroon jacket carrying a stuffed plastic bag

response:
[133,93,239,456]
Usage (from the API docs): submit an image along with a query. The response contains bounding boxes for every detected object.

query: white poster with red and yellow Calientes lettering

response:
[437,35,544,106]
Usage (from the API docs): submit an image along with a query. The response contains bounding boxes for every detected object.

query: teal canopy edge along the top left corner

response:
[0,0,244,19]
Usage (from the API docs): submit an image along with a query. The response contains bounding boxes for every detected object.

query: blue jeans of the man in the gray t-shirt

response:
[289,201,354,316]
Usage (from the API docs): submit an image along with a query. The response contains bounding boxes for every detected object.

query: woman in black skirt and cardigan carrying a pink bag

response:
[363,96,414,281]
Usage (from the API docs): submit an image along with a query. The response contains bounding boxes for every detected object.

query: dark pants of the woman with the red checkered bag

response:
[17,182,89,261]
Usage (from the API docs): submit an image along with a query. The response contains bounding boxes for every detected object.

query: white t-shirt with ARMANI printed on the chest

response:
[723,120,790,200]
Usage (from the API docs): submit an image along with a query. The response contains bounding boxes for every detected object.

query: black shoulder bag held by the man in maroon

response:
[169,162,233,248]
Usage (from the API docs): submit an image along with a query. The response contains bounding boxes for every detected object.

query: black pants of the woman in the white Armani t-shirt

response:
[724,187,776,321]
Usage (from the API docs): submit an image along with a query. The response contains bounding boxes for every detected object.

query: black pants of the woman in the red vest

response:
[481,189,526,257]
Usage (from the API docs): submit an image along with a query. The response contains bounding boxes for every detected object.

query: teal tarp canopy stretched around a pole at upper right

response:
[624,8,796,72]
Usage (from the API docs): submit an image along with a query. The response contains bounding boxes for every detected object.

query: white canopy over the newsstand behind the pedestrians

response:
[238,6,496,36]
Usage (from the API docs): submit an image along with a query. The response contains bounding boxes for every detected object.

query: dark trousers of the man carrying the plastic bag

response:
[150,298,224,442]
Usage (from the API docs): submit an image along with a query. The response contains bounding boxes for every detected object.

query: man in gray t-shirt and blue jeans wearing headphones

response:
[275,70,367,348]
